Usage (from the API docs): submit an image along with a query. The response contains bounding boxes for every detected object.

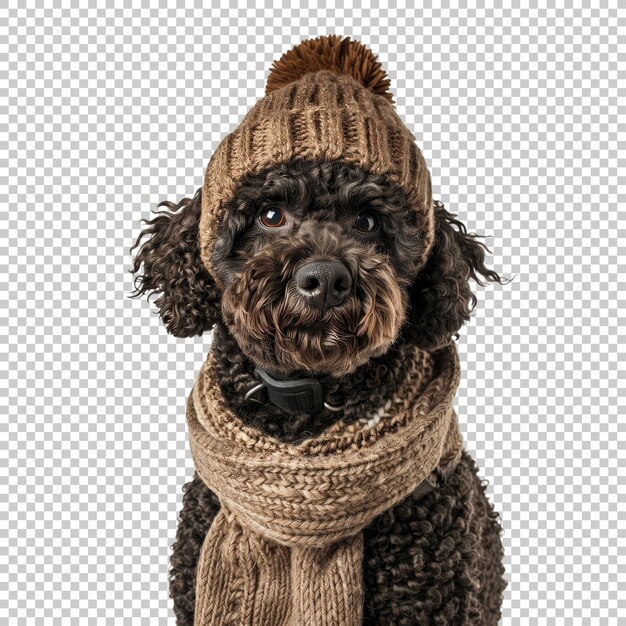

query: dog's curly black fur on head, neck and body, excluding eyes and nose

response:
[131,161,506,626]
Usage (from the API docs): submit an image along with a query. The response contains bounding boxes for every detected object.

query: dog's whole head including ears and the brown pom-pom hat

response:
[133,35,500,376]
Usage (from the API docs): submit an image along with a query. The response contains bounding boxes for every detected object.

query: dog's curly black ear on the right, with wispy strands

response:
[403,201,503,350]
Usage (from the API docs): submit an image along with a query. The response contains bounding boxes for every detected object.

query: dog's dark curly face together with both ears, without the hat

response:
[132,161,500,376]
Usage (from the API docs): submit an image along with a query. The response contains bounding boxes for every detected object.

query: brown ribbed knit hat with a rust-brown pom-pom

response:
[200,35,434,284]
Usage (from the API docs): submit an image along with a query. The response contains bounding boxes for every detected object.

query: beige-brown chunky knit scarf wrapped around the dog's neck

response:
[187,344,463,626]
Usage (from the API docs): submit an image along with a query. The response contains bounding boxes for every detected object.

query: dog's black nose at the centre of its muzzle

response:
[295,261,352,313]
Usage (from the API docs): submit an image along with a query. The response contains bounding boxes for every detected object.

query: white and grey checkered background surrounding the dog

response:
[0,2,626,626]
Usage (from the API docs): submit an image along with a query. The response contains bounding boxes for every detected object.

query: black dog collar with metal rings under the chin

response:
[245,367,343,415]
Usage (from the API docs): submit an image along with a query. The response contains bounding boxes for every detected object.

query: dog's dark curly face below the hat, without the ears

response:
[211,162,422,375]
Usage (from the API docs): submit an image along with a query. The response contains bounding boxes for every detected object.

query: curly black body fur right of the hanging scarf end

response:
[363,452,505,626]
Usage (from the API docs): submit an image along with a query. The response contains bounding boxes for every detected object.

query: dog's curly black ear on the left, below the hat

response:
[130,188,219,337]
